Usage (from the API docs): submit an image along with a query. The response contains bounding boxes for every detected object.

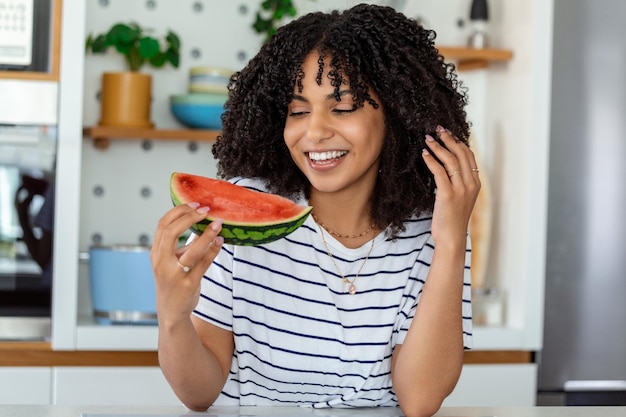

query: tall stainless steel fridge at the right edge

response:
[538,0,626,405]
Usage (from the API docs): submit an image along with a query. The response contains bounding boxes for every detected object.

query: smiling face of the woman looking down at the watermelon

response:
[284,53,385,198]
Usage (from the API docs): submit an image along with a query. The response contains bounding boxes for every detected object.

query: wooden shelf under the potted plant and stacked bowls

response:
[83,126,220,149]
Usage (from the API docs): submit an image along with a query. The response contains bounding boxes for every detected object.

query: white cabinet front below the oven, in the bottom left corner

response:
[0,367,52,404]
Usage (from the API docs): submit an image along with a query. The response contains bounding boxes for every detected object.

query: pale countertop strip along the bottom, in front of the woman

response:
[0,405,626,417]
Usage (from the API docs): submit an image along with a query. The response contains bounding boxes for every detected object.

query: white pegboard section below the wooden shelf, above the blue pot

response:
[80,140,216,250]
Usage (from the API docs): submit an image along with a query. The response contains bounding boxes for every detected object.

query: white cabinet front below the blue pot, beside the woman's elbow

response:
[52,367,181,406]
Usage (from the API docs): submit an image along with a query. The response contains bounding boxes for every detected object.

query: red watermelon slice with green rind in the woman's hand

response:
[170,172,312,246]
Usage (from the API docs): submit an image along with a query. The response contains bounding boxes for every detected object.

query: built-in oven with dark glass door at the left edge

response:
[0,126,56,340]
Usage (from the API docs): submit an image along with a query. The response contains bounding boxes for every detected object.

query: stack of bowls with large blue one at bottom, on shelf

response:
[170,67,233,130]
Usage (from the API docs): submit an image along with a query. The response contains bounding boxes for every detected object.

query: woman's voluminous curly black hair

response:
[213,4,469,237]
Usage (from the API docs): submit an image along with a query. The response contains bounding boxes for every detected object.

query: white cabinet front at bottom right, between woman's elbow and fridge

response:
[444,363,537,407]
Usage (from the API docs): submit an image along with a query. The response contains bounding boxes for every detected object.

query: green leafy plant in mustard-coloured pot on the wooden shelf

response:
[86,22,180,127]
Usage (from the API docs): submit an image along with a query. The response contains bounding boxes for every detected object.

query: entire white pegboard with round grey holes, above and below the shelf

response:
[80,0,478,251]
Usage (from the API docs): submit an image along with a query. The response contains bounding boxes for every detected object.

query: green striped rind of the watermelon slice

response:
[170,173,313,246]
